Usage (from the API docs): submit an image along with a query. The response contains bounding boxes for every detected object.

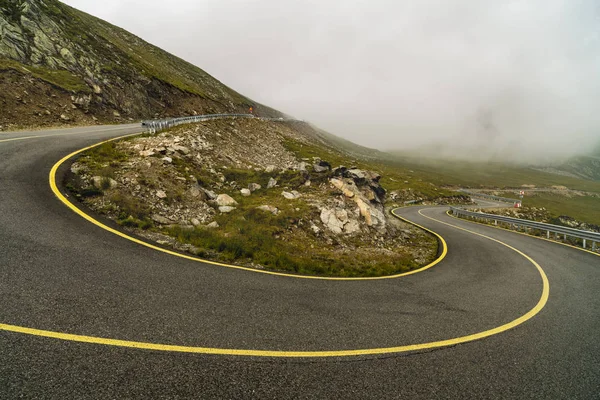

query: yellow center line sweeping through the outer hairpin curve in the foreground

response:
[0,206,550,358]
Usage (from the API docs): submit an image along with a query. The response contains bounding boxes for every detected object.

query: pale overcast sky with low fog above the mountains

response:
[65,0,600,161]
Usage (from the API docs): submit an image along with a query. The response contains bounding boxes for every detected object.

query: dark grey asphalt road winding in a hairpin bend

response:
[0,125,600,399]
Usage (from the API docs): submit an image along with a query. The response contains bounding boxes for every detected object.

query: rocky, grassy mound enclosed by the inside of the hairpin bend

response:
[67,118,437,276]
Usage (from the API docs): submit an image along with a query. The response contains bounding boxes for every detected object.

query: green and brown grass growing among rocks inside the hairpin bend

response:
[67,122,440,277]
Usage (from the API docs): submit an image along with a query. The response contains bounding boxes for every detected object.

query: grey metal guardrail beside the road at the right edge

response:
[450,207,600,251]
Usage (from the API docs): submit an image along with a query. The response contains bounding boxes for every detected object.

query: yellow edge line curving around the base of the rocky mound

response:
[43,133,448,281]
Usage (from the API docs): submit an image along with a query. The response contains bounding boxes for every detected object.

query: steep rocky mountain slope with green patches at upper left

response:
[0,0,280,130]
